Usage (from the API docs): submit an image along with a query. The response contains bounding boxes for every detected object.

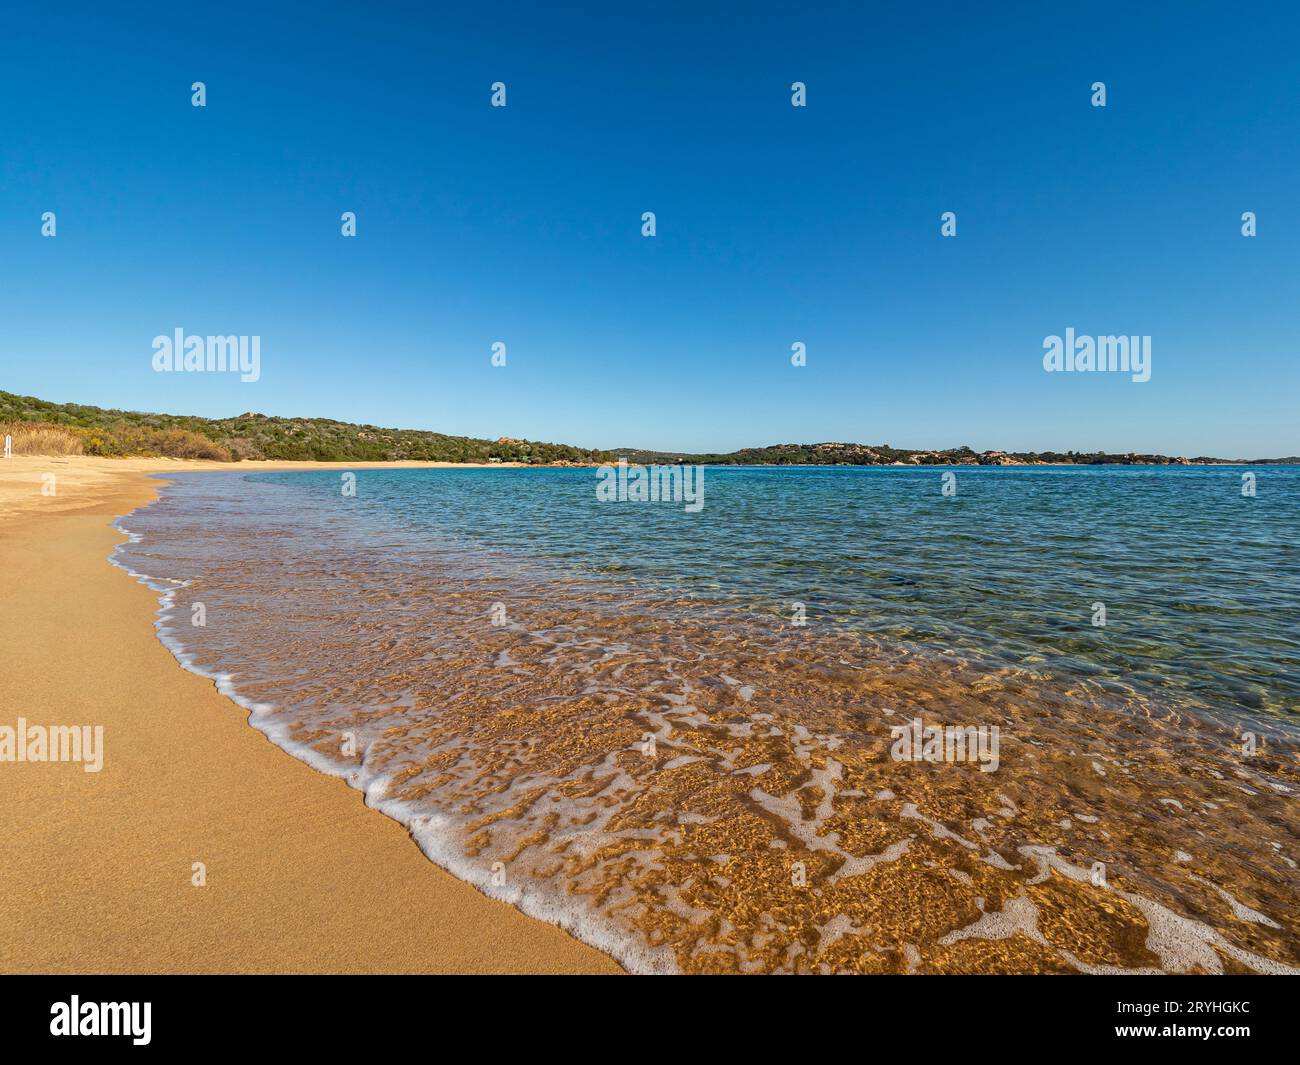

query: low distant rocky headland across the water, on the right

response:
[612,443,1300,466]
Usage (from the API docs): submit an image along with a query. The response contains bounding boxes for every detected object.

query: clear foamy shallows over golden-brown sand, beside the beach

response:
[120,473,1300,973]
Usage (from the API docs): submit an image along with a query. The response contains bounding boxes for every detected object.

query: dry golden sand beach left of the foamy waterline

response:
[0,456,620,973]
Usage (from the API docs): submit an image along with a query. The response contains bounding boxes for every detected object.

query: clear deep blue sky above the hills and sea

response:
[0,1,1300,458]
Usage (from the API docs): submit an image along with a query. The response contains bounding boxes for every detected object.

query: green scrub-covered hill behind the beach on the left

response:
[0,391,612,466]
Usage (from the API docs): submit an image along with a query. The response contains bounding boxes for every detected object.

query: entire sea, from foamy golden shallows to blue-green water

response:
[116,467,1300,971]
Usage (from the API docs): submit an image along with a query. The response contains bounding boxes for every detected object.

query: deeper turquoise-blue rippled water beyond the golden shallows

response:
[251,466,1300,718]
